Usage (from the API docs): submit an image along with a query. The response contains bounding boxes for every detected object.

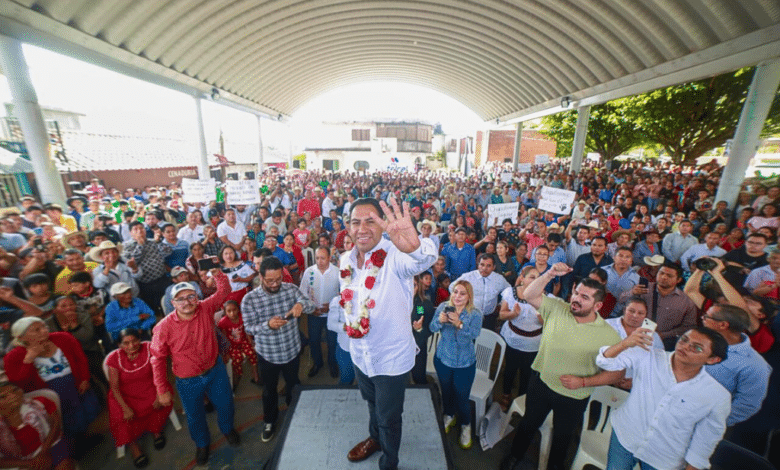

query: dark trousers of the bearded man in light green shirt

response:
[512,373,588,470]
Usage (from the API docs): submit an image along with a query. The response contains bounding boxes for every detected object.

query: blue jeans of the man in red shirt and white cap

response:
[176,356,235,447]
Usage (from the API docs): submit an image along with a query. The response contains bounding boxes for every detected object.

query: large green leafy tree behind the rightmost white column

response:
[626,68,780,165]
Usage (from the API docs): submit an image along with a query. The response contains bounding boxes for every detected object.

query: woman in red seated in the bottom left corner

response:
[0,382,75,470]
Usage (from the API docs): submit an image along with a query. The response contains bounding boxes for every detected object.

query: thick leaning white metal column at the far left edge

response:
[0,35,66,204]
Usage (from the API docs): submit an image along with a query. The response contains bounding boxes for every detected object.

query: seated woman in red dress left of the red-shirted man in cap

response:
[106,328,173,468]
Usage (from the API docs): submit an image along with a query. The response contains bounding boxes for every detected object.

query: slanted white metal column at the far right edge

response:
[715,59,780,209]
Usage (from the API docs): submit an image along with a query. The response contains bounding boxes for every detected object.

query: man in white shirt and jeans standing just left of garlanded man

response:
[300,247,339,378]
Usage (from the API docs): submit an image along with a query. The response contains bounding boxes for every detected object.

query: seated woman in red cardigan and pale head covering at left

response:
[5,317,100,453]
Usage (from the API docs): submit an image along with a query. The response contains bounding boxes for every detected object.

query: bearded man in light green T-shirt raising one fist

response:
[501,263,624,470]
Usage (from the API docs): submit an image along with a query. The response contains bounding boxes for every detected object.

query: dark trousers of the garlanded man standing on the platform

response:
[355,367,409,470]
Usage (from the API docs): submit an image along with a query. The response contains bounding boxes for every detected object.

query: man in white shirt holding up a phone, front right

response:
[596,327,731,470]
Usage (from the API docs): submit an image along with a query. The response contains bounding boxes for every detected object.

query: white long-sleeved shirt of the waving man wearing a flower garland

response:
[339,238,438,377]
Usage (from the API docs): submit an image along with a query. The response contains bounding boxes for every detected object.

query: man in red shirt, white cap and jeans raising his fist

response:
[151,269,241,465]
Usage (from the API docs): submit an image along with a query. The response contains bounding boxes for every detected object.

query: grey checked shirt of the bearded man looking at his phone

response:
[241,283,314,364]
